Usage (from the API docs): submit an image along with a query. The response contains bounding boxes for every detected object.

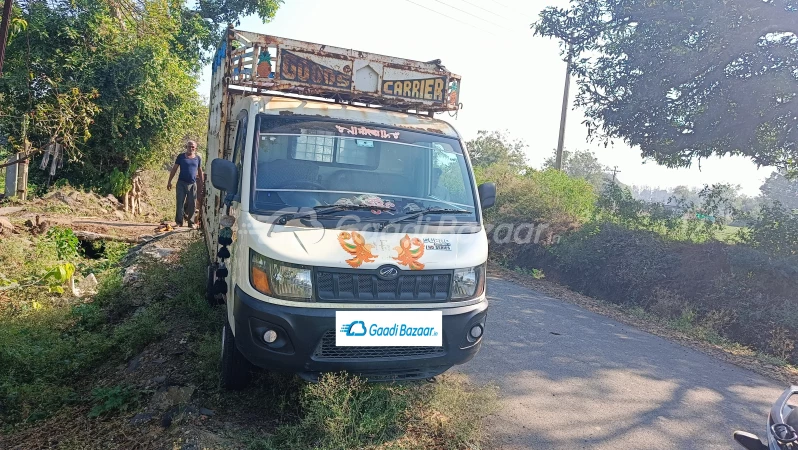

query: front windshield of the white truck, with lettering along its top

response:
[251,115,477,224]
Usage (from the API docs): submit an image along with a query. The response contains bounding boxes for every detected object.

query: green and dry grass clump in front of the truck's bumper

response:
[244,374,496,450]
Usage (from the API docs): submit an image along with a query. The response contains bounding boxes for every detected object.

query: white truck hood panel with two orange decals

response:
[245,214,488,270]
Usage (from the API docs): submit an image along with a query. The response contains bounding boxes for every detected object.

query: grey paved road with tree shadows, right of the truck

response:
[459,279,785,450]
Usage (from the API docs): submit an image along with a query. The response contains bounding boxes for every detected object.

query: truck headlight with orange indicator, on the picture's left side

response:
[249,250,313,301]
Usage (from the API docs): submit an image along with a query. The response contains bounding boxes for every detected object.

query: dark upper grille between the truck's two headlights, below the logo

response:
[316,269,452,301]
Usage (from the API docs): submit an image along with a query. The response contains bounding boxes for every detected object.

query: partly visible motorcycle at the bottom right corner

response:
[734,386,798,450]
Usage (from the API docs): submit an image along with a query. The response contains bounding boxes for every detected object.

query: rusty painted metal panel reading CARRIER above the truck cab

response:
[229,30,461,112]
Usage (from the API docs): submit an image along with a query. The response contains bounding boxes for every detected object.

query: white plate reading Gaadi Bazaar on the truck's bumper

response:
[335,311,443,347]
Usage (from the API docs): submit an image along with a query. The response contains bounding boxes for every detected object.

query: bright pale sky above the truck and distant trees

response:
[198,0,773,196]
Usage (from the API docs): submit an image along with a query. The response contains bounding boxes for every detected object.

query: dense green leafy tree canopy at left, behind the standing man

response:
[0,0,281,190]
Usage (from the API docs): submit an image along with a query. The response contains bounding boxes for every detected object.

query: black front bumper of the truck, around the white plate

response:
[233,286,488,381]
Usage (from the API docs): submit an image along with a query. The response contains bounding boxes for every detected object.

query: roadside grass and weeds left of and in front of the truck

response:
[0,222,497,450]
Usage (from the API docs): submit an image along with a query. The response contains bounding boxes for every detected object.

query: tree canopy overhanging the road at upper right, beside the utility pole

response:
[533,0,798,171]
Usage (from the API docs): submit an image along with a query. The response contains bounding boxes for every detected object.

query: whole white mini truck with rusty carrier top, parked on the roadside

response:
[201,28,496,389]
